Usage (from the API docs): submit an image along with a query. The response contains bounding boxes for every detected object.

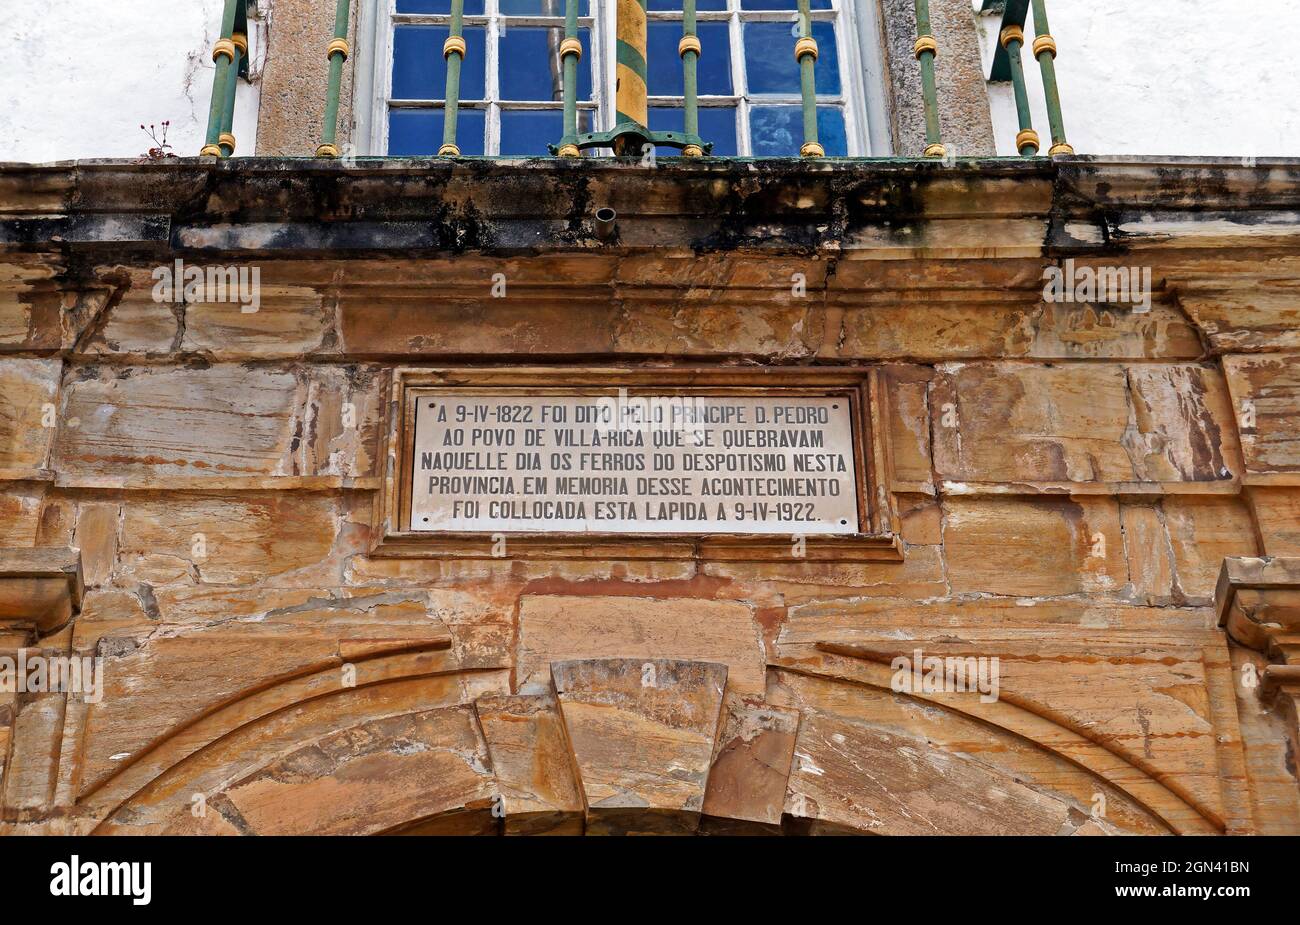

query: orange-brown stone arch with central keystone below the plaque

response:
[87,652,1204,834]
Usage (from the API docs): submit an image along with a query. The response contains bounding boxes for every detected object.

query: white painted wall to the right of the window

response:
[977,0,1300,157]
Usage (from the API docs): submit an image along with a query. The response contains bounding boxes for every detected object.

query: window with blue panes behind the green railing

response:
[358,0,871,157]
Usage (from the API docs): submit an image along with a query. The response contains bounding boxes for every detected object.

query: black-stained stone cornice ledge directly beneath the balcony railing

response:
[0,157,1300,259]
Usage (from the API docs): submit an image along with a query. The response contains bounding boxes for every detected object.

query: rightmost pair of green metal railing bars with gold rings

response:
[984,0,1074,157]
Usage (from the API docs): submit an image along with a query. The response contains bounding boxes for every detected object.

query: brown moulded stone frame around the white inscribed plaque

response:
[371,366,902,564]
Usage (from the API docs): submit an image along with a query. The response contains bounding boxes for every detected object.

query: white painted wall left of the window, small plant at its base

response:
[0,0,265,162]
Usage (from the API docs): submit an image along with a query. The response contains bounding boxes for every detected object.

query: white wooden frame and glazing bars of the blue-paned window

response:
[354,0,889,157]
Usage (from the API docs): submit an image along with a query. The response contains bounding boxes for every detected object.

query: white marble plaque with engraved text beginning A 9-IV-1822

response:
[411,391,859,535]
